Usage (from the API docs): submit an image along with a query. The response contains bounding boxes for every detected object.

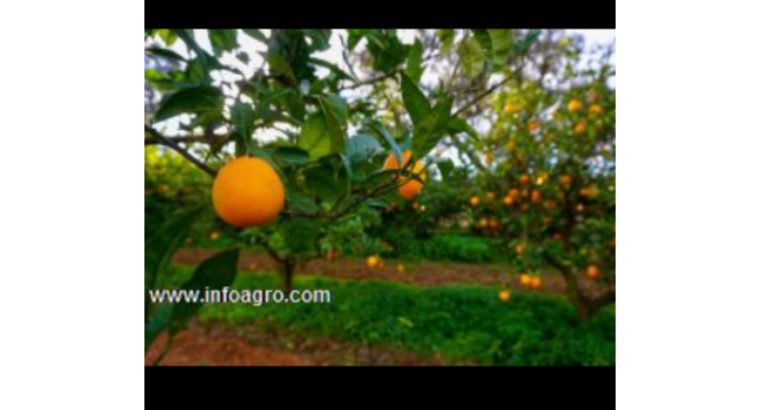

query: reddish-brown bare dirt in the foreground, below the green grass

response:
[145,323,444,366]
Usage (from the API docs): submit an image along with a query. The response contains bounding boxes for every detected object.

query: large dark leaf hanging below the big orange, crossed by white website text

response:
[168,248,240,334]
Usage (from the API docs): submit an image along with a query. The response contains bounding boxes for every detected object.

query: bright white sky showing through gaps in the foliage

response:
[145,29,615,162]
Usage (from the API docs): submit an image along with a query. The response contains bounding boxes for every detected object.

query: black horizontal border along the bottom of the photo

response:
[145,366,615,410]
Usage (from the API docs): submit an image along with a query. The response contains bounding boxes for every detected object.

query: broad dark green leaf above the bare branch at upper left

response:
[154,86,223,121]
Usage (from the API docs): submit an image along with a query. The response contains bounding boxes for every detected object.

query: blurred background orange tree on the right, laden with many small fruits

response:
[465,36,615,318]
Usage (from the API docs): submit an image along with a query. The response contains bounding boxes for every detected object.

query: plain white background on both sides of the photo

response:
[0,0,760,410]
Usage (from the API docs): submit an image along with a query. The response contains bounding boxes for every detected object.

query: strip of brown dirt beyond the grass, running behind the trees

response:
[174,249,565,293]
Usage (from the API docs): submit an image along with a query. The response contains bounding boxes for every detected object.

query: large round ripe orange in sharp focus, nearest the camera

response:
[212,157,285,228]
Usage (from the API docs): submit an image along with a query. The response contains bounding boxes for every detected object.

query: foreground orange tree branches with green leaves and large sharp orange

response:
[145,30,540,356]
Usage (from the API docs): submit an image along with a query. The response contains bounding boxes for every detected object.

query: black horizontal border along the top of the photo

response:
[145,0,615,29]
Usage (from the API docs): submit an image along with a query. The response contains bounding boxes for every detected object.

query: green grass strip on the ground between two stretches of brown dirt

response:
[165,267,615,365]
